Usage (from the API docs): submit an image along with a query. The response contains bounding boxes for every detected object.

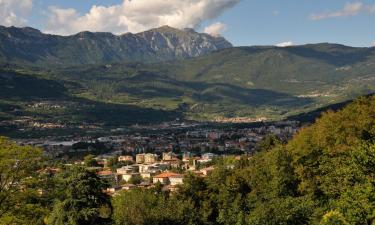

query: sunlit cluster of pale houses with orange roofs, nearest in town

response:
[97,152,216,194]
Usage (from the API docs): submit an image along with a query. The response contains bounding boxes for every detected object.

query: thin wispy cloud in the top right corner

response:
[310,2,375,20]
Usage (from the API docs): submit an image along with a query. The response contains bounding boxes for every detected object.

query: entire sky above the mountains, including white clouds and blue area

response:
[0,0,375,46]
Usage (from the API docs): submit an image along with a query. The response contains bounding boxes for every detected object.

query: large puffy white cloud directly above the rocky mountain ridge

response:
[45,0,241,35]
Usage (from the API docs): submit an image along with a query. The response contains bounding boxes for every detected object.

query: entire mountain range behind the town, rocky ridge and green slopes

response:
[0,26,375,136]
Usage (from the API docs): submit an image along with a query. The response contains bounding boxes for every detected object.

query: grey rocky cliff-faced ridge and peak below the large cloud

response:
[0,26,232,65]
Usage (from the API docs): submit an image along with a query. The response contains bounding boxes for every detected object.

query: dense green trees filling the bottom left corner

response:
[0,138,112,225]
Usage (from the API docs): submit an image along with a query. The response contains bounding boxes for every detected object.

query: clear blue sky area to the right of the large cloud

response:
[212,0,375,46]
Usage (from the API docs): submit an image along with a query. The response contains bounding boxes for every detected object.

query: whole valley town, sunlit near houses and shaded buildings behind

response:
[23,121,299,194]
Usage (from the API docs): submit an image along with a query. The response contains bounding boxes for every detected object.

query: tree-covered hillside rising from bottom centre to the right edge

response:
[113,97,375,225]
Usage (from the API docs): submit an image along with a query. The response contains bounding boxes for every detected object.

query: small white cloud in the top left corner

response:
[0,0,33,26]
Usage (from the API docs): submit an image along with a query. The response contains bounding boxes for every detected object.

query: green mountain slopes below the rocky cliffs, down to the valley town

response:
[0,39,375,134]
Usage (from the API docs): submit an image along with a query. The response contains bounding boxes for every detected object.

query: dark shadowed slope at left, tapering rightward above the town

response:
[0,66,181,137]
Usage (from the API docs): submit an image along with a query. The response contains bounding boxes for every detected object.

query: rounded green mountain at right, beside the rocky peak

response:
[163,44,375,94]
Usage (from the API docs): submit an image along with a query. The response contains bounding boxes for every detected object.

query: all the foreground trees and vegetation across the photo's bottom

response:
[0,96,375,225]
